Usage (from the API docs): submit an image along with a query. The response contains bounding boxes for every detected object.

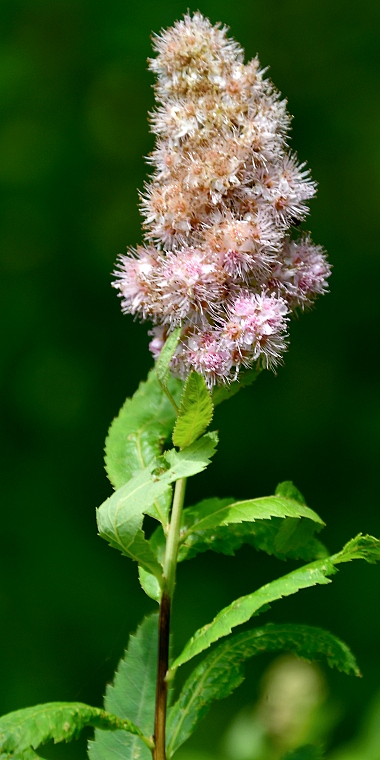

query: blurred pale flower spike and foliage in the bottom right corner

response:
[171,655,380,760]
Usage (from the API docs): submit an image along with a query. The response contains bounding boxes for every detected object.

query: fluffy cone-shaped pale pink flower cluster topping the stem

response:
[114,13,330,386]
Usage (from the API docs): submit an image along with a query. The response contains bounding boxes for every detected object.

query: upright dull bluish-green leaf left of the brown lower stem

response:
[89,614,158,760]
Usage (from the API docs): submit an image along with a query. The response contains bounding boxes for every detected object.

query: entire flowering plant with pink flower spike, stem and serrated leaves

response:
[0,13,380,760]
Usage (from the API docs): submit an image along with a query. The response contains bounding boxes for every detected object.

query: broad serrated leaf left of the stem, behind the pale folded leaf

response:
[105,369,183,523]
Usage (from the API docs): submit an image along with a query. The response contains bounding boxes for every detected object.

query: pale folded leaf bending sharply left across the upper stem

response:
[97,433,217,578]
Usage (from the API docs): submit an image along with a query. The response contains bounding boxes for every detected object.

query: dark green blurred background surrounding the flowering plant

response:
[0,0,380,760]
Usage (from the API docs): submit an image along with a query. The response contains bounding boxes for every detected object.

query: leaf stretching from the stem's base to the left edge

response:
[0,702,145,754]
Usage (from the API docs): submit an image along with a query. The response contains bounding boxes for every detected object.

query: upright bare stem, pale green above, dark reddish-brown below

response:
[153,478,186,760]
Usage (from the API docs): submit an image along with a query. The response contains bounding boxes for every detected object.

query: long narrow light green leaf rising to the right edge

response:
[169,534,380,674]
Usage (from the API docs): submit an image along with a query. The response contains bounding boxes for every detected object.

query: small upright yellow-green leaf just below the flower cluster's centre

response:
[173,372,214,449]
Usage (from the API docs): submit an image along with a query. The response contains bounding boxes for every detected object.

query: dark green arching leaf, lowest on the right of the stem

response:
[167,624,360,757]
